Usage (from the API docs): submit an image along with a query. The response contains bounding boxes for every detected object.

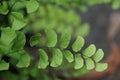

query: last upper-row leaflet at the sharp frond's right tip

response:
[93,49,104,62]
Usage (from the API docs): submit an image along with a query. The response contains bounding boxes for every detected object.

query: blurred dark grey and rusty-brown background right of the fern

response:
[74,5,120,80]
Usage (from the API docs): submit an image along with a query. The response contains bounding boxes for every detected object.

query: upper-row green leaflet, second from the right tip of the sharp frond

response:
[83,44,96,57]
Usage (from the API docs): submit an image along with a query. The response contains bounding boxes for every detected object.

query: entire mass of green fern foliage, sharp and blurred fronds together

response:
[0,0,118,80]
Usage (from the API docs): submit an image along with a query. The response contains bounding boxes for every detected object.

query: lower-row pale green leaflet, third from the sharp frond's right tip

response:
[74,54,84,69]
